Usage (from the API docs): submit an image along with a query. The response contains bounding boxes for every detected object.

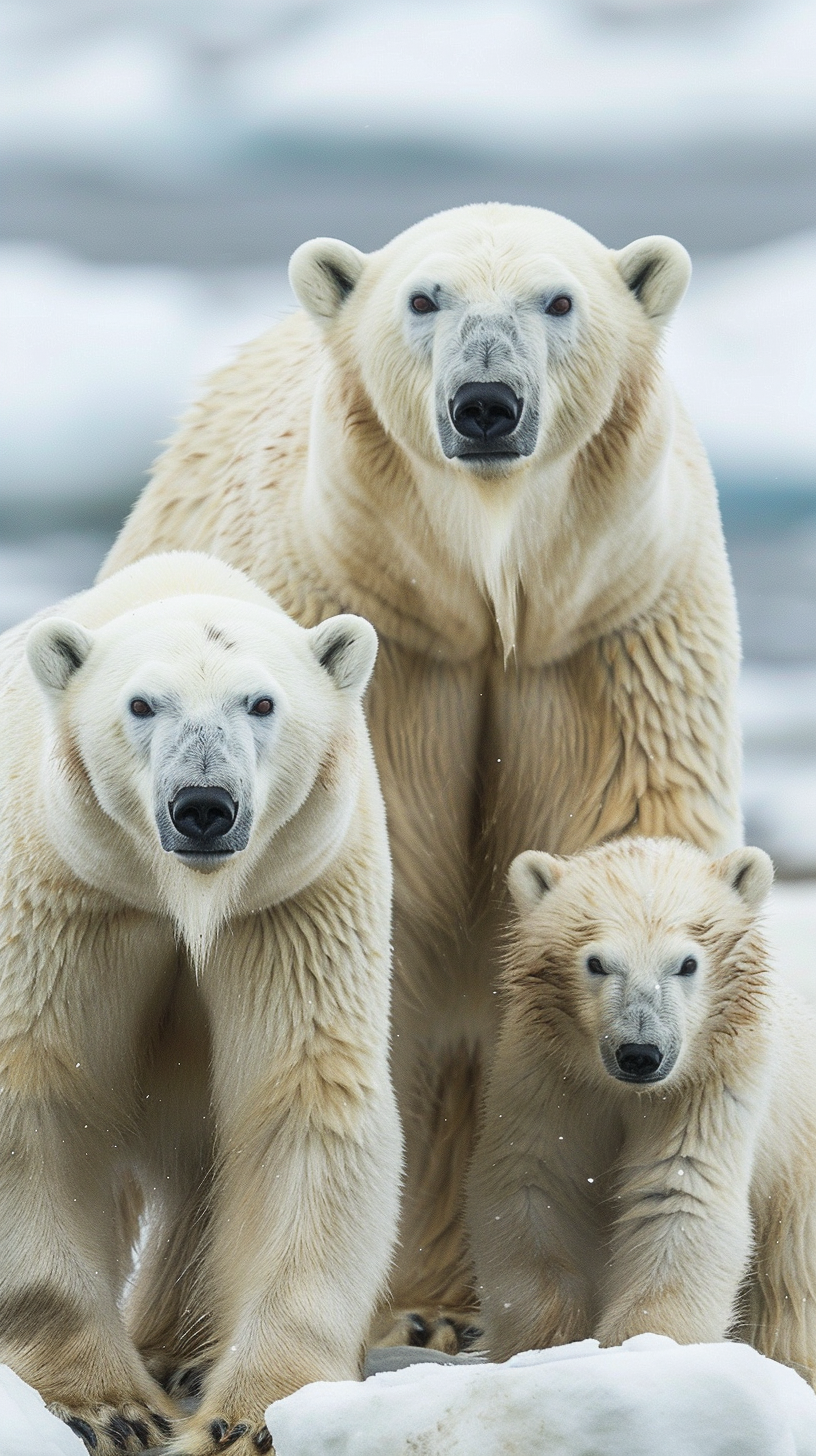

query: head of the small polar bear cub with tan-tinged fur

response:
[509,839,774,1091]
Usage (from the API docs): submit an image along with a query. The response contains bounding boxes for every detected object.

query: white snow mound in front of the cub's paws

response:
[267,1335,816,1456]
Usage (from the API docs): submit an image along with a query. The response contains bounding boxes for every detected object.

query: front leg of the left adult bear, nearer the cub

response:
[170,917,401,1456]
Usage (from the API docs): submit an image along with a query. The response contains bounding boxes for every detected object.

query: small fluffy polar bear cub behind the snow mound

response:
[469,839,816,1383]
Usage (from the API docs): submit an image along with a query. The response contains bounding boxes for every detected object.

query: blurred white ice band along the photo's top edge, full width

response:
[0,0,816,176]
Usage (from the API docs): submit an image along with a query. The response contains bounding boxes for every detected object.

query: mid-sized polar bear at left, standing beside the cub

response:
[0,553,401,1456]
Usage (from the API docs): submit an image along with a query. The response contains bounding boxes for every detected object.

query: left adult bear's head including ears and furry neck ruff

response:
[26,588,376,955]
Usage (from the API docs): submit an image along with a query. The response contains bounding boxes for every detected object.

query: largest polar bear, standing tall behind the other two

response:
[105,204,740,1342]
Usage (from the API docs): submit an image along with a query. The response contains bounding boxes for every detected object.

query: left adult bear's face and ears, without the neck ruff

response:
[28,596,376,872]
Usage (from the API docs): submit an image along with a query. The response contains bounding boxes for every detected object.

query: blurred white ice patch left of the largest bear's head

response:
[0,245,291,502]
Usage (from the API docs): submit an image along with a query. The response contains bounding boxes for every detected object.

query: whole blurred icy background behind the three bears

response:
[0,0,816,943]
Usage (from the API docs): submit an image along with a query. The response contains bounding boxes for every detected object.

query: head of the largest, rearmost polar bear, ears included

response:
[290,204,689,479]
